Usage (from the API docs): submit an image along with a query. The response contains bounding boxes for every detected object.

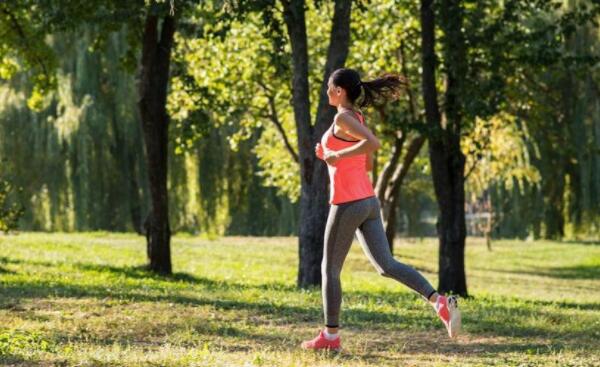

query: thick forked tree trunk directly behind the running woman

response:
[282,0,351,288]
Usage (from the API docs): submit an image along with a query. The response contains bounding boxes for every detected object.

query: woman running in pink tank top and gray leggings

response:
[302,69,461,350]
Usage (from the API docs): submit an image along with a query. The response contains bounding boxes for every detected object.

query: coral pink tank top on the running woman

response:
[321,112,375,204]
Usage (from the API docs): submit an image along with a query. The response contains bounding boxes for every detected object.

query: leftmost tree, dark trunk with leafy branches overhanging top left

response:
[3,0,193,274]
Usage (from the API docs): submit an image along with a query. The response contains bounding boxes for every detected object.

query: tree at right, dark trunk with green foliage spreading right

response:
[421,0,598,295]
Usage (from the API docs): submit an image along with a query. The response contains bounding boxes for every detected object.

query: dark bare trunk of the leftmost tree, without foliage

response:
[138,14,175,274]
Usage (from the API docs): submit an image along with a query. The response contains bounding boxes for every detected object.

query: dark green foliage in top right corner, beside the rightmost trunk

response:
[461,0,600,125]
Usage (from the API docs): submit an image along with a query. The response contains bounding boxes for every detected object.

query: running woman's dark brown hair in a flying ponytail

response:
[331,68,406,107]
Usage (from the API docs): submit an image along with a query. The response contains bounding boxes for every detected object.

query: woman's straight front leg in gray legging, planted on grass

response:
[321,200,369,330]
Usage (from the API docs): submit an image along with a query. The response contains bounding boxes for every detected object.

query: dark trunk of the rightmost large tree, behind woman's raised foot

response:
[421,0,468,296]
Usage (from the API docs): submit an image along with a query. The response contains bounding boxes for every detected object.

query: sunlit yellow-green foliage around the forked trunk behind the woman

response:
[169,1,426,201]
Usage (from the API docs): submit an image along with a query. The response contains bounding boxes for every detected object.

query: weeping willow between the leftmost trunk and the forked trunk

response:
[169,123,297,237]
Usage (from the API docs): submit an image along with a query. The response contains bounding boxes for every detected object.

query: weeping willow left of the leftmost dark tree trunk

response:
[0,27,145,231]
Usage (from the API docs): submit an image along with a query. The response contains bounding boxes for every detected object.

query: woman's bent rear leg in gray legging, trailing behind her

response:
[357,198,436,300]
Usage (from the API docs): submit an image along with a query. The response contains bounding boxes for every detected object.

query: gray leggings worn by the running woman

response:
[321,197,435,327]
